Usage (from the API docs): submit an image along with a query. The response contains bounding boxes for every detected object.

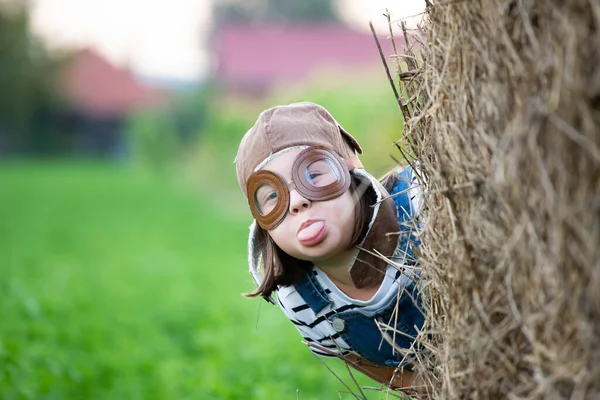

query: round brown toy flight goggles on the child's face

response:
[246,146,362,230]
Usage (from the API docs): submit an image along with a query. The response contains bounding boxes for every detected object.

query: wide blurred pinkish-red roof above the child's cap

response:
[214,23,404,91]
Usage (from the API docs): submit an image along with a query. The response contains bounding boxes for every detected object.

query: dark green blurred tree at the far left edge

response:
[0,1,63,152]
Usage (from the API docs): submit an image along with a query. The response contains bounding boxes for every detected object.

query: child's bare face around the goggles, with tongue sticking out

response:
[262,149,355,265]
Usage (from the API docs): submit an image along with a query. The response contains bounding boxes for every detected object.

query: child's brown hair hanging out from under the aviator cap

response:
[245,172,397,298]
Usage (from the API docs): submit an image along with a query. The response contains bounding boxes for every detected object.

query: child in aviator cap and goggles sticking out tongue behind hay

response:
[236,102,424,387]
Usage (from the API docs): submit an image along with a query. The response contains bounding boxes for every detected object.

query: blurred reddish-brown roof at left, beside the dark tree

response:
[63,49,166,116]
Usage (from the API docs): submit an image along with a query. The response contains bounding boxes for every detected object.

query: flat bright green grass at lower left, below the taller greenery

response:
[0,162,385,400]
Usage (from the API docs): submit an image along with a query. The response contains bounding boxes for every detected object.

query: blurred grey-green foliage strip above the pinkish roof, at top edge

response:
[212,0,339,27]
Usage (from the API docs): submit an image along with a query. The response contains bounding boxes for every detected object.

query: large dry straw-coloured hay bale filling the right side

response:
[398,0,600,399]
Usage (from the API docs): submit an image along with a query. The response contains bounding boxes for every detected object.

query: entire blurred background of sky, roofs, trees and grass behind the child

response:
[0,0,424,400]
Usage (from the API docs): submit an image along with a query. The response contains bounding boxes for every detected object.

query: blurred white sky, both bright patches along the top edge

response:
[32,0,425,80]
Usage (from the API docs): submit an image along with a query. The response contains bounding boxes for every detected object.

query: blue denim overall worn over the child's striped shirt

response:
[295,167,424,367]
